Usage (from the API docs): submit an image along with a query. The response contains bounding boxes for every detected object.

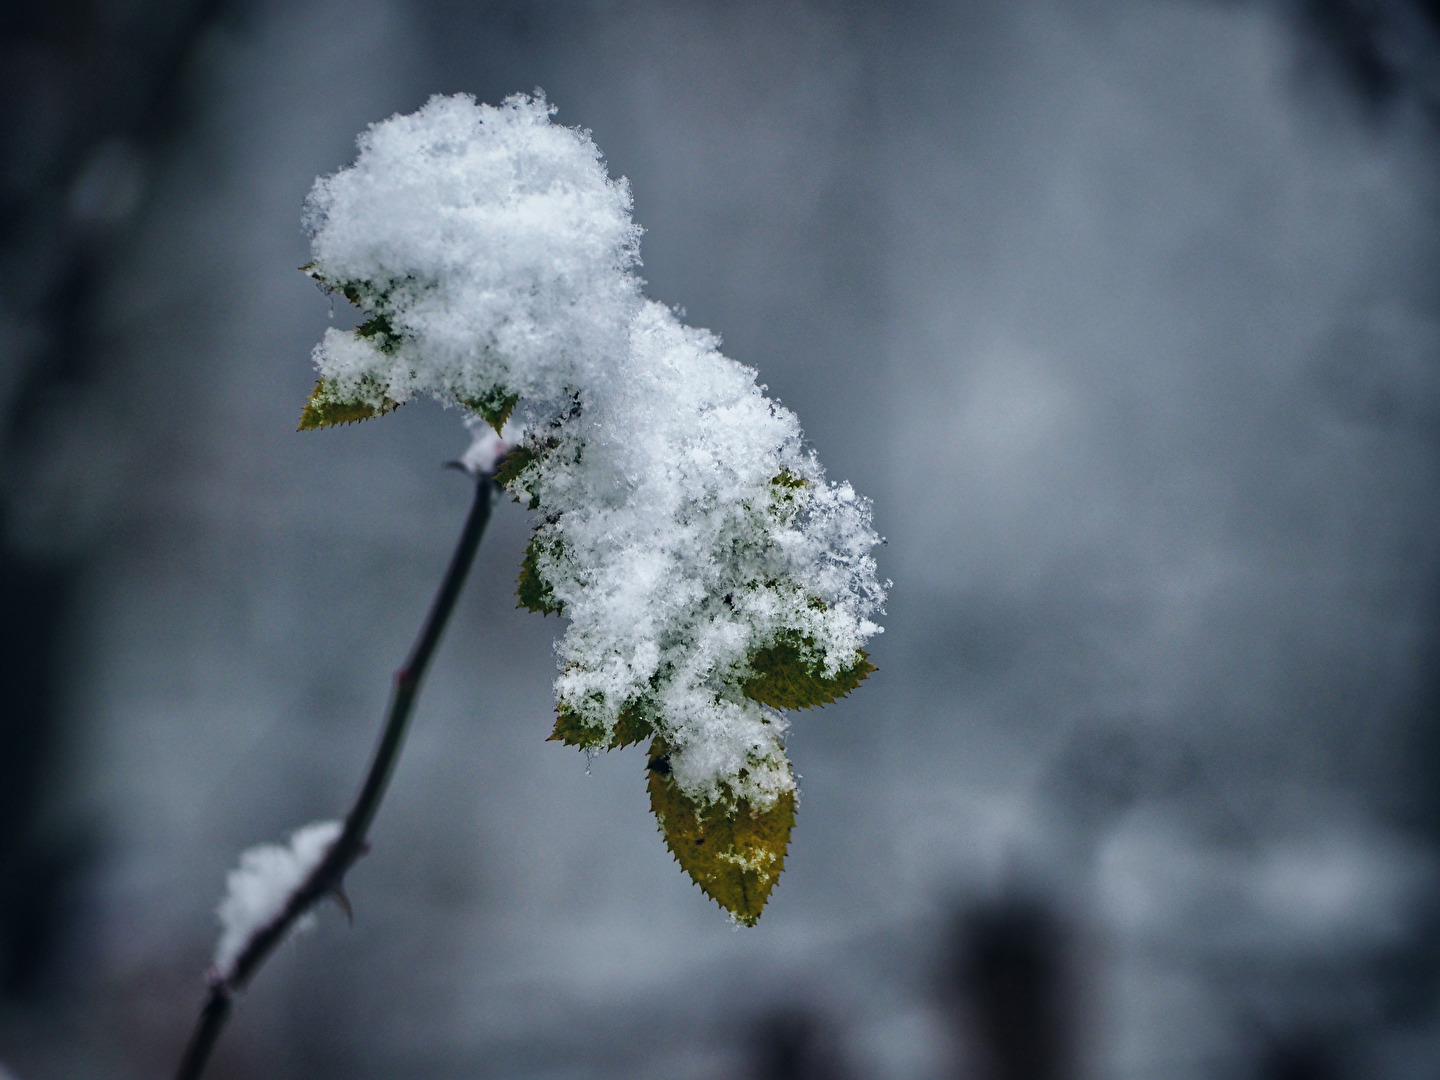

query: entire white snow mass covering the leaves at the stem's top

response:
[307,95,884,808]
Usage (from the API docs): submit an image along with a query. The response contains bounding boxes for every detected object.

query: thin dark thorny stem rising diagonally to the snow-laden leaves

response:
[176,472,494,1080]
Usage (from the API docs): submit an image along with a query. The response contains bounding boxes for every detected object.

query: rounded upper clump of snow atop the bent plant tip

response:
[305,95,639,405]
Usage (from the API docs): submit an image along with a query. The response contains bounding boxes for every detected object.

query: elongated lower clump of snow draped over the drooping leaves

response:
[518,302,883,806]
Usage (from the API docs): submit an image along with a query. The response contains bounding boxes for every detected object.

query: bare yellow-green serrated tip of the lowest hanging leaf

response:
[648,739,795,926]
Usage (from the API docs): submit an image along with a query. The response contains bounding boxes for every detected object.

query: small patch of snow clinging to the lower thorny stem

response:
[215,821,341,979]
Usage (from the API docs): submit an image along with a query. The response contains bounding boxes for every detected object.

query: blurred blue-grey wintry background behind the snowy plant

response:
[0,0,1440,1080]
